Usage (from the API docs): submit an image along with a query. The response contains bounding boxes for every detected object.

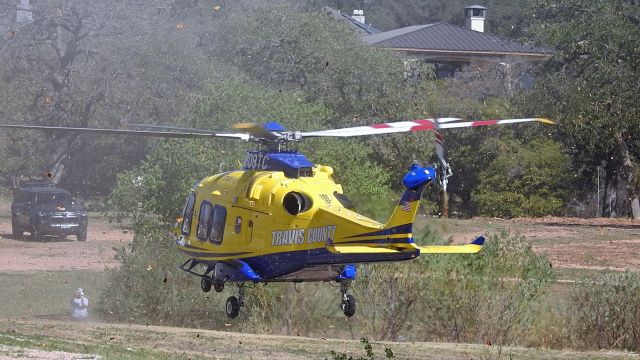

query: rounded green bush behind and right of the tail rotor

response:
[472,140,572,217]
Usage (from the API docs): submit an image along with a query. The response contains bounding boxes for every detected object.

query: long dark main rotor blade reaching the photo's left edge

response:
[0,124,250,140]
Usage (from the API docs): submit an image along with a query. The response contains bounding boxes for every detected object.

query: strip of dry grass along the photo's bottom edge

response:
[0,320,638,360]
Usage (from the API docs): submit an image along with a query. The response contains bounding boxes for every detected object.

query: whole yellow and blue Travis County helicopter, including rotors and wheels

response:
[0,118,553,318]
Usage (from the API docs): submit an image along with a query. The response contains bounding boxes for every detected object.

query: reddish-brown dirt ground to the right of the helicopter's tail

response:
[422,217,640,271]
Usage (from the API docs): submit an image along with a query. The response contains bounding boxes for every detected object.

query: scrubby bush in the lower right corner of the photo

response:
[568,271,640,351]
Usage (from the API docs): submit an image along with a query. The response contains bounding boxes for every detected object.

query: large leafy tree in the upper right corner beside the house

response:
[520,0,640,218]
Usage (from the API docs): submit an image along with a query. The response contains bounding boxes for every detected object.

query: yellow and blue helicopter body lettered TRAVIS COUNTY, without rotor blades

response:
[177,152,435,282]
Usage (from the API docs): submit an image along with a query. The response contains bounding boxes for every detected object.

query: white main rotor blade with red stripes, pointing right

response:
[301,118,554,138]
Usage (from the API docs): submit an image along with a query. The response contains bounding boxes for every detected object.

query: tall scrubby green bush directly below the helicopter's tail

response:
[356,233,553,344]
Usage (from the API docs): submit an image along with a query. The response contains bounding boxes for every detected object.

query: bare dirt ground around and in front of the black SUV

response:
[0,218,133,272]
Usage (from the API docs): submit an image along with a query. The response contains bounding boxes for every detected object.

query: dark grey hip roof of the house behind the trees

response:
[363,22,553,58]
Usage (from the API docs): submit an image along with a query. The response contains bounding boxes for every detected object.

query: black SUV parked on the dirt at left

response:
[11,184,88,241]
